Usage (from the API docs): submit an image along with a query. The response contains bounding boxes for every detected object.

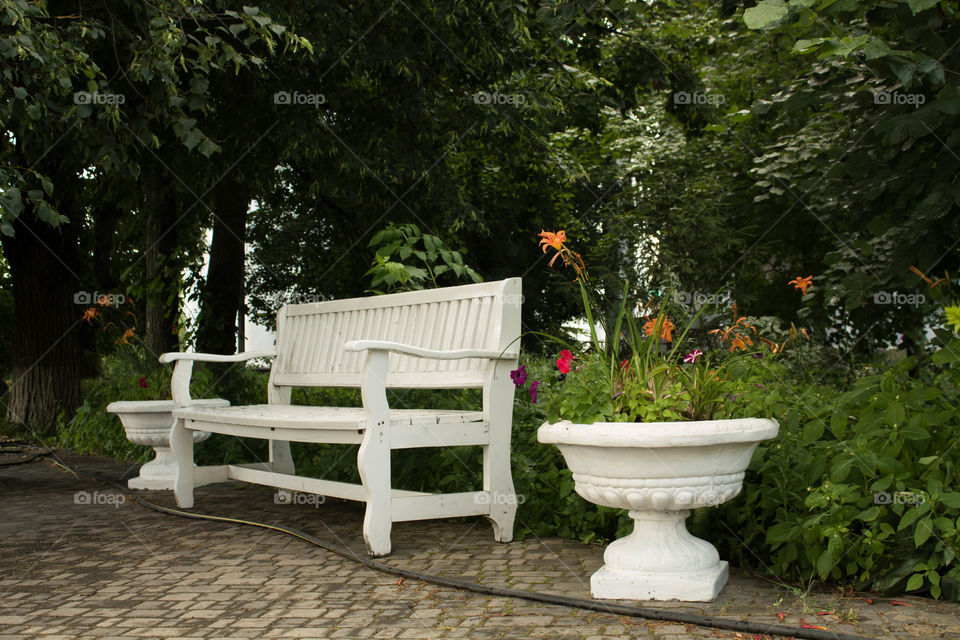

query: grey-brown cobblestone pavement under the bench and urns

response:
[0,453,960,640]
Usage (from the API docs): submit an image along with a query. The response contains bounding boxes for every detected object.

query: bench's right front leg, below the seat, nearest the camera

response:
[357,426,393,557]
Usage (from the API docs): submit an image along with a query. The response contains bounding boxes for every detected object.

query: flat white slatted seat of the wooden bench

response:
[173,404,483,431]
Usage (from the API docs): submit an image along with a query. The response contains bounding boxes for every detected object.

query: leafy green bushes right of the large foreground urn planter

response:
[695,345,960,600]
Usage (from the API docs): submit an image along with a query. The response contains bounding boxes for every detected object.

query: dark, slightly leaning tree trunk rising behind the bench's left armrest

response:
[197,177,250,354]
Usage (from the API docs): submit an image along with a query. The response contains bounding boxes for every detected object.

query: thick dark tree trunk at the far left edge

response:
[3,202,82,438]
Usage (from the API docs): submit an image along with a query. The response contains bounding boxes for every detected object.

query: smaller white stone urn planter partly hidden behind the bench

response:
[107,398,230,490]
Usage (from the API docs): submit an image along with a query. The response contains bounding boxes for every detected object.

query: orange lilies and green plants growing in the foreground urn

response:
[530,231,784,424]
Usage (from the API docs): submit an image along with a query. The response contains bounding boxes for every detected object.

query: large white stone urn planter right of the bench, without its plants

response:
[537,418,779,602]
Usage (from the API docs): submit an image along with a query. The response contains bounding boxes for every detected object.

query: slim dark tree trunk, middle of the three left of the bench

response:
[144,164,180,356]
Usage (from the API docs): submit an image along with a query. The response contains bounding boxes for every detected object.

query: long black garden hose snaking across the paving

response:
[0,443,876,640]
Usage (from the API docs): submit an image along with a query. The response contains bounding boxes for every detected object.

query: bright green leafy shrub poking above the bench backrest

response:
[364,223,483,293]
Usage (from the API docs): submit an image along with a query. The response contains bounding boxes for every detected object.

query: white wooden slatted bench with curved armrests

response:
[160,278,522,556]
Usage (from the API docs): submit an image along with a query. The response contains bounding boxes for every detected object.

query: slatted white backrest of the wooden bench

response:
[271,278,523,388]
